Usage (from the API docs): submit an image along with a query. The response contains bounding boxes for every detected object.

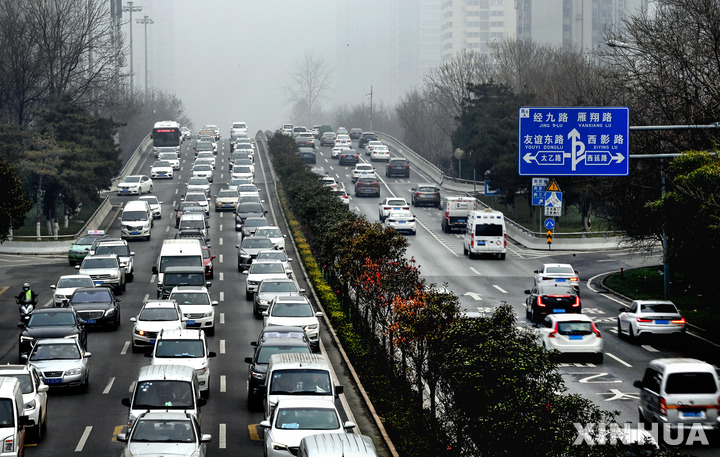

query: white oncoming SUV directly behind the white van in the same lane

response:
[146,329,217,398]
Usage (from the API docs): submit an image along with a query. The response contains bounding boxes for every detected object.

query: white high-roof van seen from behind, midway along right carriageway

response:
[463,208,507,260]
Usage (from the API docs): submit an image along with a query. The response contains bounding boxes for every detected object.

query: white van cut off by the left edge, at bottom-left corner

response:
[0,377,35,456]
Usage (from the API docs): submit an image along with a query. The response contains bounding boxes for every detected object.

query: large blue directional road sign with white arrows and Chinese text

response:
[518,107,630,176]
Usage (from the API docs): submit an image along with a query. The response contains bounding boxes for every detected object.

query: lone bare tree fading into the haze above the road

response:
[286,52,331,126]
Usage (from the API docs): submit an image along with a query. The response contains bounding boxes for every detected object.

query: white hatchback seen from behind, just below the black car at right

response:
[538,313,603,363]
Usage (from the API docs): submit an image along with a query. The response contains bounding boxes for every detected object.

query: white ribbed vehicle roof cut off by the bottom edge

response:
[297,433,377,457]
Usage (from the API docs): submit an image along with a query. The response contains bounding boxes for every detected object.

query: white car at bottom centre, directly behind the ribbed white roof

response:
[260,399,355,457]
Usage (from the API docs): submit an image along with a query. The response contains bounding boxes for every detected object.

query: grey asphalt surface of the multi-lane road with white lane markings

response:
[0,130,718,456]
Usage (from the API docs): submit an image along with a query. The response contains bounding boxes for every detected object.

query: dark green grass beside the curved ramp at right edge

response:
[604,265,720,341]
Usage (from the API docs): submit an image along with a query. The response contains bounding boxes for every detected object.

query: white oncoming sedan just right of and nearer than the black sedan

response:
[130,300,185,352]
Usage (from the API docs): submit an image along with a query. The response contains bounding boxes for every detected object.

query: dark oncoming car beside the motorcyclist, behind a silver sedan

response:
[18,308,87,363]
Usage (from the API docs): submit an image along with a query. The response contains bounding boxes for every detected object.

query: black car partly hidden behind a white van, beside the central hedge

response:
[245,334,312,408]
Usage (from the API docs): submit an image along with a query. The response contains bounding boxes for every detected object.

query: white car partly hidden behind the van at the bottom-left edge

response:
[0,364,48,443]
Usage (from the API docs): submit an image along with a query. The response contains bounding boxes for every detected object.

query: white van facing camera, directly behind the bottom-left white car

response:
[122,365,207,428]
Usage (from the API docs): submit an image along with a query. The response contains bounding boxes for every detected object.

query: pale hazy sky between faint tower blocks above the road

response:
[167,0,342,134]
